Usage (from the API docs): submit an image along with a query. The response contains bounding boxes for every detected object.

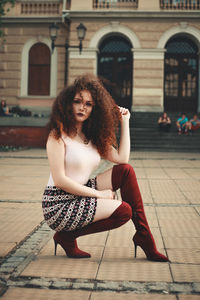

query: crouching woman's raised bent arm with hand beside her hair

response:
[105,107,130,164]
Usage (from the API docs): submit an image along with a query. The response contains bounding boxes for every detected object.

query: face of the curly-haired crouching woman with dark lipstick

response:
[72,90,94,123]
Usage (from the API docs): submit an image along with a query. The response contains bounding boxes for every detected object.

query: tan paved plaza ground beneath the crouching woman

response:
[0,149,200,300]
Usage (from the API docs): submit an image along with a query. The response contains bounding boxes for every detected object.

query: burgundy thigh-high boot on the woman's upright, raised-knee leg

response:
[112,164,169,262]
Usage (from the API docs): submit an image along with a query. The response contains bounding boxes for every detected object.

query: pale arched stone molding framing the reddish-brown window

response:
[20,35,57,98]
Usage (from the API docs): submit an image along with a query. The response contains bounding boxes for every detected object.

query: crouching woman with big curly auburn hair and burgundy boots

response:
[42,75,168,262]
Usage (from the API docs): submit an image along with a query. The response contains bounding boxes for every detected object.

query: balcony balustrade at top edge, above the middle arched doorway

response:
[93,0,138,9]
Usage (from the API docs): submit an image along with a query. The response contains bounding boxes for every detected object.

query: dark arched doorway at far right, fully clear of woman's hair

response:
[164,36,199,112]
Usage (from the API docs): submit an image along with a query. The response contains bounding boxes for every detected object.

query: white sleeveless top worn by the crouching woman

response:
[47,137,101,186]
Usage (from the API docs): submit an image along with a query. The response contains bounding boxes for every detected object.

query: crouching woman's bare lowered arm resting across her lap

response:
[47,134,113,199]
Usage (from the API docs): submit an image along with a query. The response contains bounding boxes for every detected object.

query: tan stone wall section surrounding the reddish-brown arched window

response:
[0,24,66,110]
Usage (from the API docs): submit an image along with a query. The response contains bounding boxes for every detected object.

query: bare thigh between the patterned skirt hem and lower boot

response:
[93,199,121,222]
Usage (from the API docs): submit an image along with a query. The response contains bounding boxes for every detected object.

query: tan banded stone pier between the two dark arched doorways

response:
[132,49,165,111]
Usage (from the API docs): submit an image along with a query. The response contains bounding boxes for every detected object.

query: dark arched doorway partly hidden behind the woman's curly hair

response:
[98,35,133,110]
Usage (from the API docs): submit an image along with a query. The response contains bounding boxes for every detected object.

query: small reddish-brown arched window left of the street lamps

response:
[28,43,50,96]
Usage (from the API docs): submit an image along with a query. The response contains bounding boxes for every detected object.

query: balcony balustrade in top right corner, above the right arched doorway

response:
[160,0,200,10]
